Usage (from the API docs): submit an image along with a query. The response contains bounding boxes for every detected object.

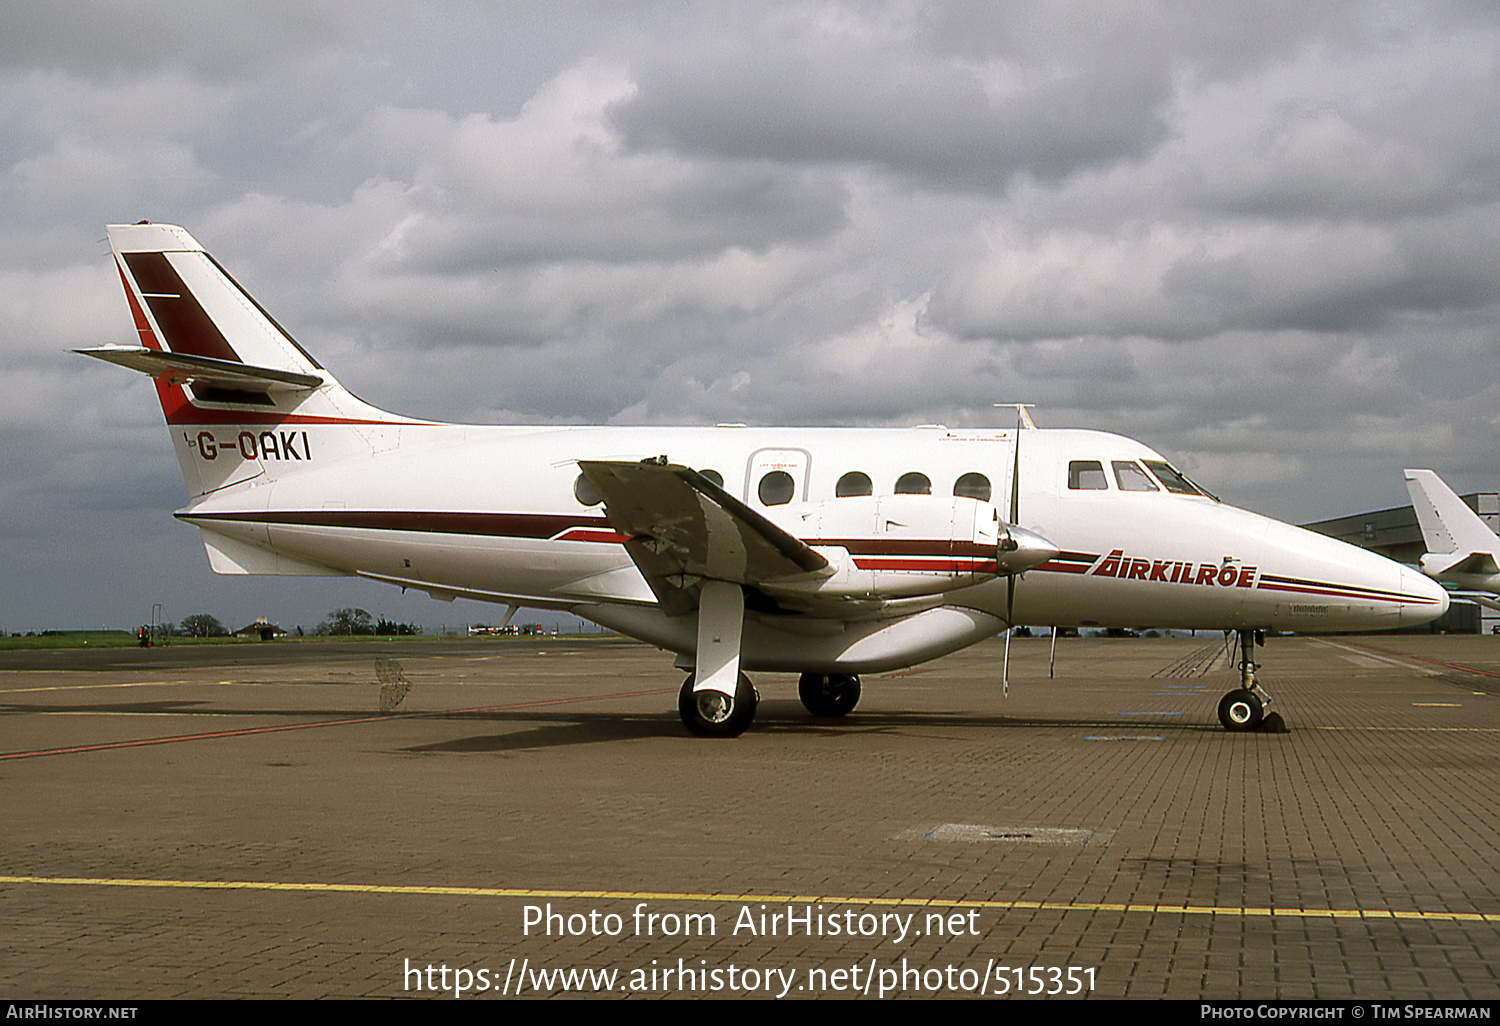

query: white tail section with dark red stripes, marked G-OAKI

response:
[80,222,422,500]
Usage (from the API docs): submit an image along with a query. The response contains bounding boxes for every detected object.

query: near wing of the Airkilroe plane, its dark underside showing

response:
[579,461,834,614]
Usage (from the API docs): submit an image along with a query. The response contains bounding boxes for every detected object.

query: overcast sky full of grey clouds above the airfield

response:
[0,0,1500,630]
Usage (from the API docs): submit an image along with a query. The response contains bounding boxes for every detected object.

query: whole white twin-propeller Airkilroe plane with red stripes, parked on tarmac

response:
[81,222,1448,737]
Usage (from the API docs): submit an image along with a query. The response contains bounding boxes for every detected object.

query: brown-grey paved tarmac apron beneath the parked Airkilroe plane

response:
[0,636,1500,1001]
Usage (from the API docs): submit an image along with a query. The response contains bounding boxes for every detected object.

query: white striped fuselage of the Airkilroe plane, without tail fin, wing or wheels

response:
[174,423,1442,672]
